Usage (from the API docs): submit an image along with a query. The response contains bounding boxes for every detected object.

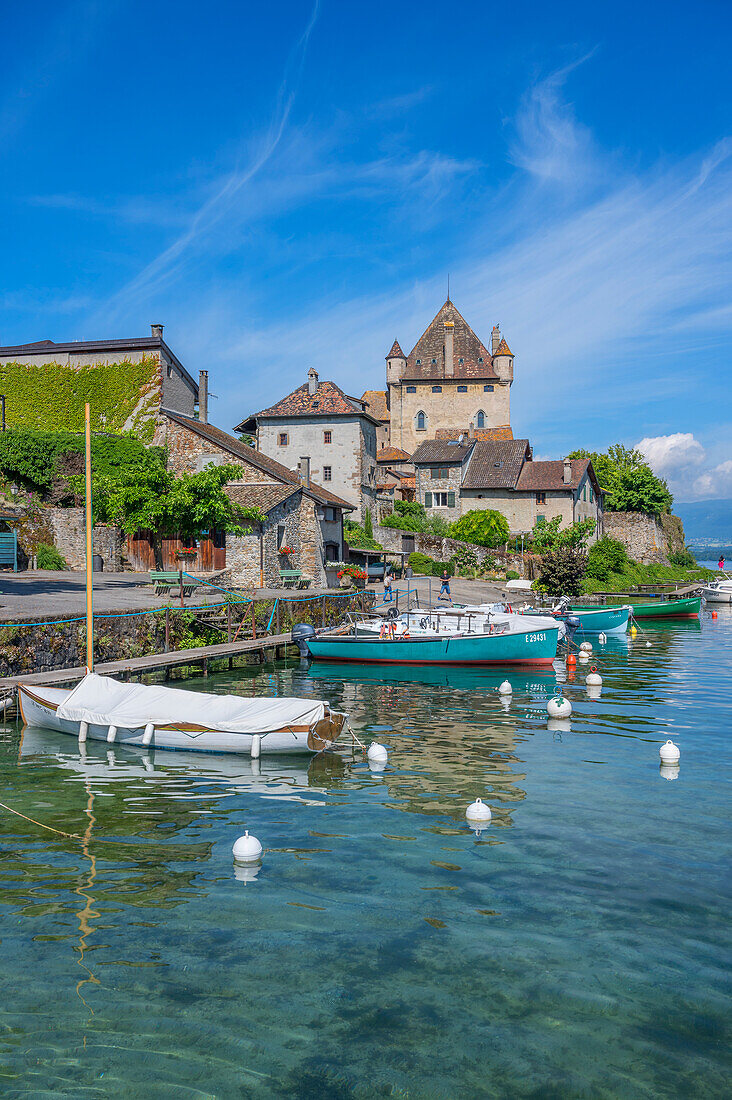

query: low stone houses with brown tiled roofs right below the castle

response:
[413,438,603,538]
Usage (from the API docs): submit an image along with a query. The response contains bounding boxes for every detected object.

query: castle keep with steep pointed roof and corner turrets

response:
[361,298,514,452]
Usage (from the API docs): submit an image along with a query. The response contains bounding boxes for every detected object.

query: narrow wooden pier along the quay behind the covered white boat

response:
[0,633,293,691]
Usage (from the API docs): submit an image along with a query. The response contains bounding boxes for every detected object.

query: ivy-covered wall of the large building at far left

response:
[0,355,162,442]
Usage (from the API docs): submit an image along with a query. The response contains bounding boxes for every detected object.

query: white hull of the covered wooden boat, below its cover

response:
[18,684,345,756]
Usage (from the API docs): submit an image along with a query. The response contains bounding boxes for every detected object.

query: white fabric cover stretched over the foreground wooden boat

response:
[56,672,326,734]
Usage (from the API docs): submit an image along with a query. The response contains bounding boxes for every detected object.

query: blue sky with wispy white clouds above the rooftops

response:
[0,0,732,499]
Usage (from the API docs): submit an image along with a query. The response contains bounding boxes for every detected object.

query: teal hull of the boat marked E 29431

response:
[308,626,559,666]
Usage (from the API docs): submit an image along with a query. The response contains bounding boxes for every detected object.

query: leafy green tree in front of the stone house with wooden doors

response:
[94,454,260,569]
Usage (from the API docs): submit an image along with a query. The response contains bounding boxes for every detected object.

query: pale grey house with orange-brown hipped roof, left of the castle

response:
[234,369,381,521]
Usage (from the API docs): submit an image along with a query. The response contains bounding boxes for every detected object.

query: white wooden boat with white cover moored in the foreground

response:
[18,672,346,758]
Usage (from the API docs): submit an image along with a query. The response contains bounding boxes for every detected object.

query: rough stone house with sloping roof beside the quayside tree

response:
[155,409,352,587]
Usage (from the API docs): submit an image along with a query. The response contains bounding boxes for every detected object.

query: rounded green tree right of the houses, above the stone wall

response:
[569,443,674,516]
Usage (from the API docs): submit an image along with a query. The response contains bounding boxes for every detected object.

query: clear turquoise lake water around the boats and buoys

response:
[0,607,732,1098]
